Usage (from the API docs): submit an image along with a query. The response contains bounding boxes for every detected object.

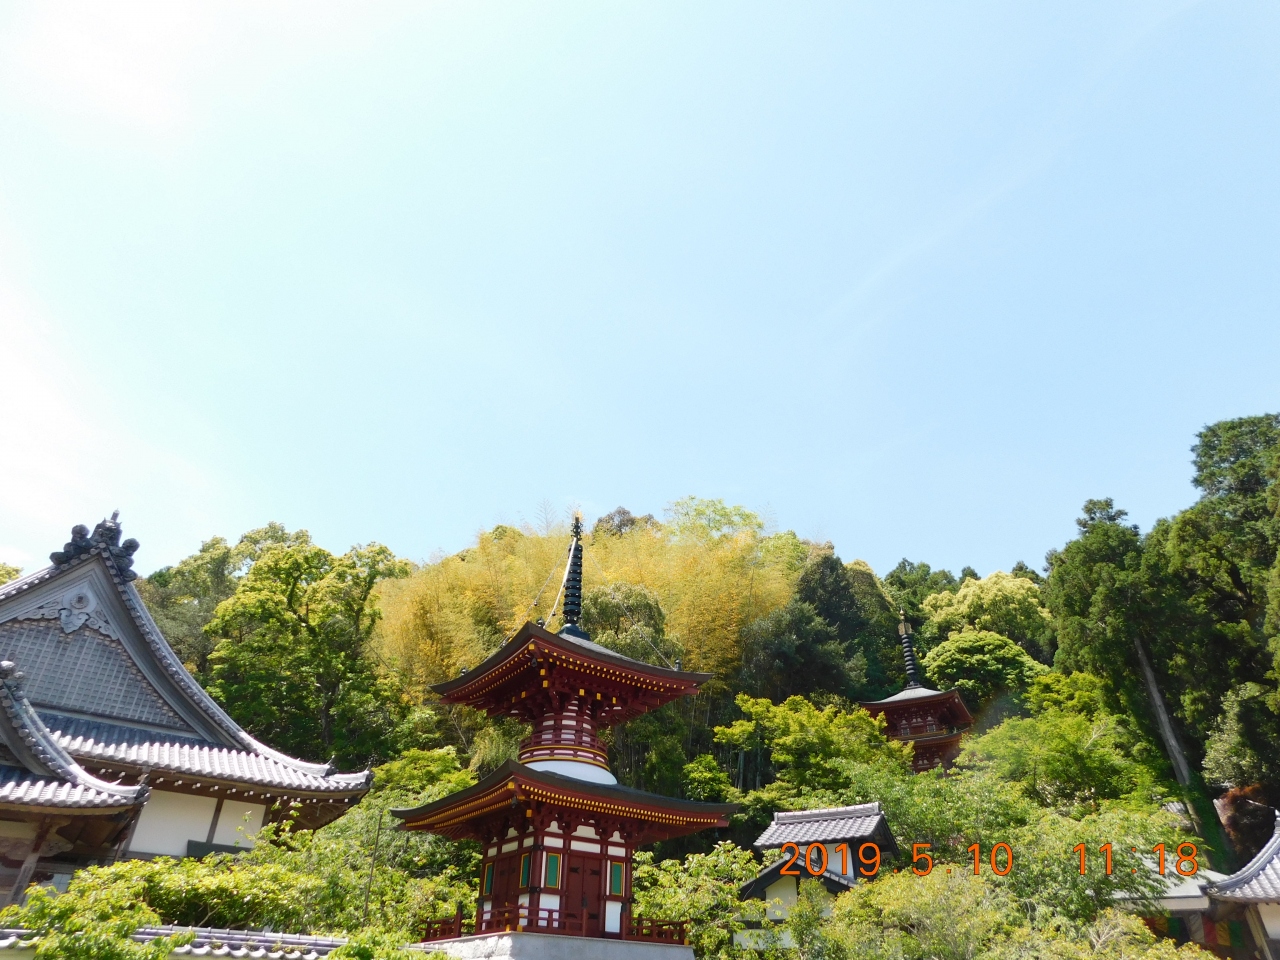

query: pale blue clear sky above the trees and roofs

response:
[0,0,1280,573]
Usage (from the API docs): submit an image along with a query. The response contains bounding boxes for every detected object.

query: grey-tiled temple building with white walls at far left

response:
[0,515,371,900]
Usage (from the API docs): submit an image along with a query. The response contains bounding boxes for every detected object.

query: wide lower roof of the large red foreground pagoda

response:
[392,760,737,844]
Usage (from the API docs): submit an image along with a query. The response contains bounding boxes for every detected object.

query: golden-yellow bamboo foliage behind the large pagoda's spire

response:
[379,498,810,682]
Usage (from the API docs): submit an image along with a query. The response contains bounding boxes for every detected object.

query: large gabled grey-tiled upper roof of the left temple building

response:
[0,516,372,799]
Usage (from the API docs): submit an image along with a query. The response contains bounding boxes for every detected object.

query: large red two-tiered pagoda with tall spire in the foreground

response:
[392,518,736,955]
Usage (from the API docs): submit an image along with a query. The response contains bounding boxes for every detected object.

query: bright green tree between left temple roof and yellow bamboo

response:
[207,541,410,764]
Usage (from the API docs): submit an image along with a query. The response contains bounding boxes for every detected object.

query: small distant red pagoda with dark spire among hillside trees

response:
[861,611,973,773]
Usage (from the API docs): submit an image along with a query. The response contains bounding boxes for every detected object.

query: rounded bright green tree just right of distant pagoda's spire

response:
[924,632,1044,713]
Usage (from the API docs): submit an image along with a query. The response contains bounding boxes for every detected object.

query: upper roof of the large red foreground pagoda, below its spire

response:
[431,623,713,705]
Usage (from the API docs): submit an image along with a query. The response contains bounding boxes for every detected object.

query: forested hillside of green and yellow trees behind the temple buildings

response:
[5,415,1280,956]
